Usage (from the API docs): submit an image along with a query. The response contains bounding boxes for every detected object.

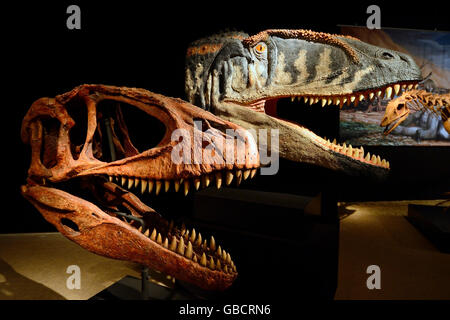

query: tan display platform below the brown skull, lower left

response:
[0,233,171,300]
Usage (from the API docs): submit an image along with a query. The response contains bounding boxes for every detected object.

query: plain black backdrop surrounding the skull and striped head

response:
[0,1,450,232]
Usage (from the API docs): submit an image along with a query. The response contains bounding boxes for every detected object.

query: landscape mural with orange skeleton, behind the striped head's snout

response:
[340,26,450,146]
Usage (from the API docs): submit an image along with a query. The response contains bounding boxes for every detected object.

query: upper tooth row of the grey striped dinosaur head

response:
[291,82,418,108]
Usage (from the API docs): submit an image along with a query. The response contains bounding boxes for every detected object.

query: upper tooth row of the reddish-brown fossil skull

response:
[108,168,257,195]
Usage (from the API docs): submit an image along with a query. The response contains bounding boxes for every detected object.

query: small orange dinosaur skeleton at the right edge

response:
[380,90,450,135]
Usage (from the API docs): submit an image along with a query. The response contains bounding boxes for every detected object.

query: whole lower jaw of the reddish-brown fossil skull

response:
[21,179,237,290]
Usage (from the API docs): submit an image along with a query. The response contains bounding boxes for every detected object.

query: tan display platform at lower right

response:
[335,200,450,300]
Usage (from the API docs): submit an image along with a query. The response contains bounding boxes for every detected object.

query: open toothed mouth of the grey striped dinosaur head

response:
[243,81,418,169]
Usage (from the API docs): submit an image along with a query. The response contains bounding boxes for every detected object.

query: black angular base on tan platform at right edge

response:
[406,204,450,253]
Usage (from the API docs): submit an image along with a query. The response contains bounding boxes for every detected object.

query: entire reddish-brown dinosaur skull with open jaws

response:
[21,85,259,290]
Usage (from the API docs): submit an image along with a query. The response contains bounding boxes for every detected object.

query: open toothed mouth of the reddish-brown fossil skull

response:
[52,169,256,277]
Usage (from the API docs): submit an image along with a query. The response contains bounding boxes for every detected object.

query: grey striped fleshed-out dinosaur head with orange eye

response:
[185,29,421,176]
